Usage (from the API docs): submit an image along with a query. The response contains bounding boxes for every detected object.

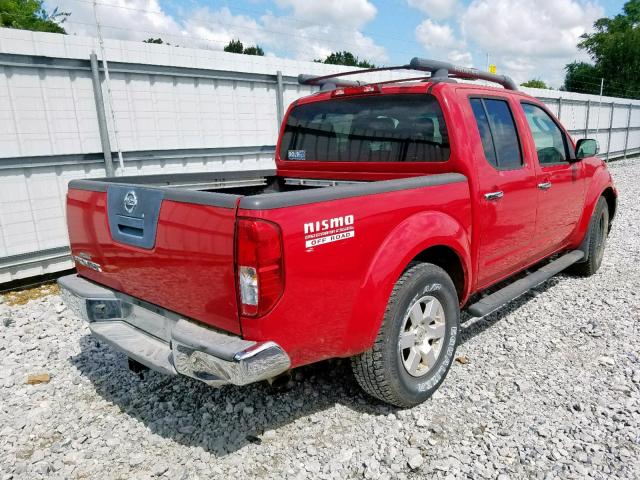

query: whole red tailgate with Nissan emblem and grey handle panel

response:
[67,180,240,334]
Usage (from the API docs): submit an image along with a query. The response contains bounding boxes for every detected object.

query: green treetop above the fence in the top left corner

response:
[0,0,71,33]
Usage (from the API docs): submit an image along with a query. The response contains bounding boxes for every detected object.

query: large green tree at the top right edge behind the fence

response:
[565,0,640,98]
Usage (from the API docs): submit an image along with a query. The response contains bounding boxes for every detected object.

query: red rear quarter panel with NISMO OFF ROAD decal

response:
[238,182,471,366]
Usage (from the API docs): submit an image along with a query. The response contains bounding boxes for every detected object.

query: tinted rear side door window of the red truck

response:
[470,98,523,170]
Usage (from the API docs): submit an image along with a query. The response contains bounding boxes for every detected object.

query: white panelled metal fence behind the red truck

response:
[0,29,640,284]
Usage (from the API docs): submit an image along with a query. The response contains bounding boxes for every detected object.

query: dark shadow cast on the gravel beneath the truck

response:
[71,279,556,456]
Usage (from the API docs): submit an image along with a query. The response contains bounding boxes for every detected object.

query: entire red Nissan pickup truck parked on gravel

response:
[59,59,617,407]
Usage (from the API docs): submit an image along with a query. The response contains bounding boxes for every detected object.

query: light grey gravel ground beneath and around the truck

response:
[0,160,640,480]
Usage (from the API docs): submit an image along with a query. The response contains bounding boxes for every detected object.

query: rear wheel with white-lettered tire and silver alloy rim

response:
[351,263,460,408]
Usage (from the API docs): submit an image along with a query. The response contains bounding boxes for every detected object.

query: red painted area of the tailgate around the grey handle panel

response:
[67,189,240,334]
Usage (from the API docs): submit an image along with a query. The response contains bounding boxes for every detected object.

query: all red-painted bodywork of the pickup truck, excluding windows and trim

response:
[68,83,616,366]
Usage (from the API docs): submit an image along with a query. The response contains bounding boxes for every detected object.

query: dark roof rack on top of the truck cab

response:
[298,57,518,91]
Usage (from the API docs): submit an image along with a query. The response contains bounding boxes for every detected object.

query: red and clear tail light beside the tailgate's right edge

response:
[236,218,284,317]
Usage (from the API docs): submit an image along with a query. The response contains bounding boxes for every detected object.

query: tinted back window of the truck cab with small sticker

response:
[280,94,450,162]
